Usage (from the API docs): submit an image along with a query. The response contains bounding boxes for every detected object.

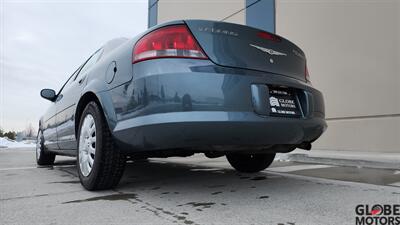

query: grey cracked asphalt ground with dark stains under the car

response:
[0,149,400,225]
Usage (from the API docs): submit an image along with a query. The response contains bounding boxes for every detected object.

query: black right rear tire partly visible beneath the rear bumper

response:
[226,153,275,173]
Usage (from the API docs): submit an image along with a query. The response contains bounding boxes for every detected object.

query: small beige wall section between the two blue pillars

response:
[157,0,245,24]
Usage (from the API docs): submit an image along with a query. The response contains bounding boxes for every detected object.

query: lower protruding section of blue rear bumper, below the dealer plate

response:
[114,112,326,152]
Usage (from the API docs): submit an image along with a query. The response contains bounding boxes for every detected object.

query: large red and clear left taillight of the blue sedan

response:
[132,25,207,63]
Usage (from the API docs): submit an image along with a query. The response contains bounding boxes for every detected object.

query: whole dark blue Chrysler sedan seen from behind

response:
[36,20,327,190]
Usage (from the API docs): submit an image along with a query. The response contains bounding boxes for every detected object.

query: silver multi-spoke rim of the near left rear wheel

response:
[79,114,96,177]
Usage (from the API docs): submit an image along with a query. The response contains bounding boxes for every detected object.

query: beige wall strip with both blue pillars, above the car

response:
[149,0,275,32]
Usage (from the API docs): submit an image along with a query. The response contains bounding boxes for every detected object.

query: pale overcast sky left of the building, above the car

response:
[0,0,148,131]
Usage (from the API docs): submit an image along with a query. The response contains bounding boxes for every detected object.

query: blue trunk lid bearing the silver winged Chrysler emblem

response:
[185,20,306,81]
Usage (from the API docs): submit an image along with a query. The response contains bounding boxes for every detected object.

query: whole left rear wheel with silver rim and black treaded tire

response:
[77,102,126,190]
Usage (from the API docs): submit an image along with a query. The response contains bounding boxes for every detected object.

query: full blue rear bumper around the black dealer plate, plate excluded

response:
[108,59,326,152]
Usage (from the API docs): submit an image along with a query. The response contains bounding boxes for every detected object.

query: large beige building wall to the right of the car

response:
[276,0,400,152]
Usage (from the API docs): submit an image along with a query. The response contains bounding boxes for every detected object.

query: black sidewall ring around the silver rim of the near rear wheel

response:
[76,102,103,189]
